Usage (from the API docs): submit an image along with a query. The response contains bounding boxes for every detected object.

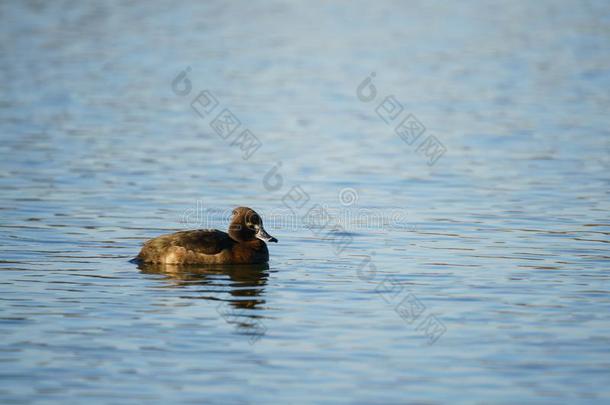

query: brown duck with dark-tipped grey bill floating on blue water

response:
[135,207,277,265]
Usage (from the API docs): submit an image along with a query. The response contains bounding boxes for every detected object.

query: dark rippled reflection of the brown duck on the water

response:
[138,263,269,343]
